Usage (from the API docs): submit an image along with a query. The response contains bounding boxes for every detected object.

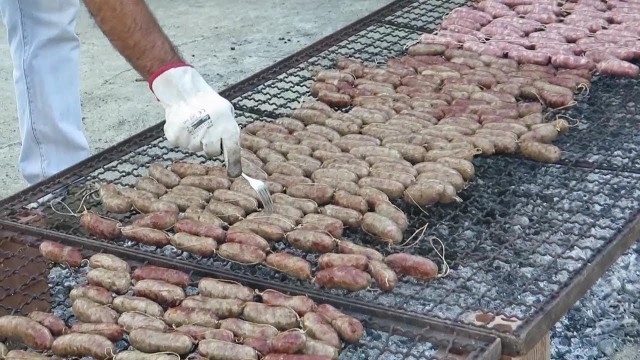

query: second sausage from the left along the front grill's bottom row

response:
[51,333,115,359]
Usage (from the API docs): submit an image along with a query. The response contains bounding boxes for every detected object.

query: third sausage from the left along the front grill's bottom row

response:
[129,328,193,355]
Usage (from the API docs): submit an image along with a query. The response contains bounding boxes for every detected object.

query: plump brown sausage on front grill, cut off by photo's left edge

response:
[0,315,54,351]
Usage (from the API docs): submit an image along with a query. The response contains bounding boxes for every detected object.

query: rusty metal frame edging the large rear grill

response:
[0,0,640,356]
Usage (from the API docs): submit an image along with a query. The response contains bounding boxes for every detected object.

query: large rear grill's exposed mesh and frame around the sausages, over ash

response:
[2,0,640,355]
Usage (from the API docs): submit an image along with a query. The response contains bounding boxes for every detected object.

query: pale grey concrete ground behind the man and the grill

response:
[0,0,640,360]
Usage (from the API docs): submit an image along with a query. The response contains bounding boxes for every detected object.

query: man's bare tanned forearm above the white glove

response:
[84,0,183,80]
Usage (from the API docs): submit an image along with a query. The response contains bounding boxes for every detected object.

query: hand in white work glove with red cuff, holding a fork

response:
[149,63,242,177]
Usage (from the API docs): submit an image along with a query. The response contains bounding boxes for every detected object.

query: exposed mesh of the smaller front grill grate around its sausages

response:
[0,232,499,360]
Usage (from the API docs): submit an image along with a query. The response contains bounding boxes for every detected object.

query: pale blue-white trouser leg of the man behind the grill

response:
[0,0,89,185]
